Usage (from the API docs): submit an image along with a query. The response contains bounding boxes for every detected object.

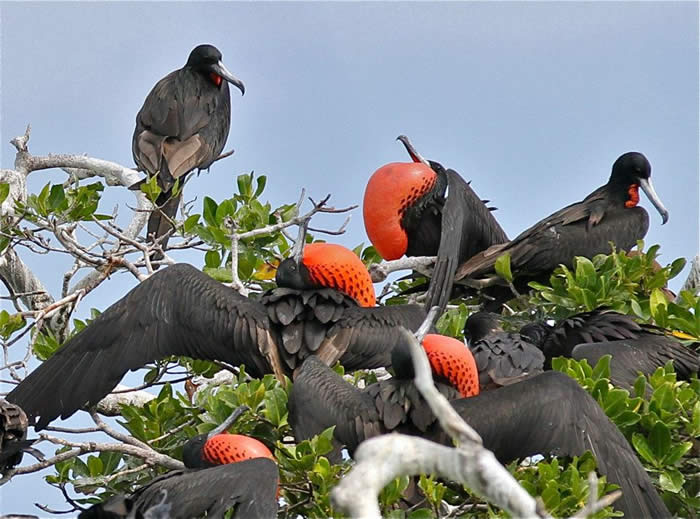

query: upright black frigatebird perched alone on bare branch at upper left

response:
[131,45,245,259]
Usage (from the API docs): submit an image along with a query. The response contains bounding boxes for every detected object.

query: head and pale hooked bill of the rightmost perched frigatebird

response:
[608,151,668,225]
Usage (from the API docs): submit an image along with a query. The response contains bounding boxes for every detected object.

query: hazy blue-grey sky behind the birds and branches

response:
[0,1,699,513]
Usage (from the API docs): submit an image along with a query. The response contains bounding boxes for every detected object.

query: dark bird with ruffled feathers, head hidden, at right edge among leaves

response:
[520,308,700,389]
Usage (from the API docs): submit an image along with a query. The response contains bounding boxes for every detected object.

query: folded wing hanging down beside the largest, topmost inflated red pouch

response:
[426,169,508,311]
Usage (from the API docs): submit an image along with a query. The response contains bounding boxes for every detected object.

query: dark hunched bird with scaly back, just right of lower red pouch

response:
[464,312,545,391]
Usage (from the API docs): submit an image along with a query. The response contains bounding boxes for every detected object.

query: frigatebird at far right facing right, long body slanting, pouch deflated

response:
[455,152,668,294]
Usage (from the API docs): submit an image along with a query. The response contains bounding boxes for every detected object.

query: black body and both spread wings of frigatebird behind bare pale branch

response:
[289,348,671,517]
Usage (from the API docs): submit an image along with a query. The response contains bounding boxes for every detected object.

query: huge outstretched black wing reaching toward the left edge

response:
[7,264,281,429]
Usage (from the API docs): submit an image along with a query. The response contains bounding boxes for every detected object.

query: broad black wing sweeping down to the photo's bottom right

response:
[429,371,671,517]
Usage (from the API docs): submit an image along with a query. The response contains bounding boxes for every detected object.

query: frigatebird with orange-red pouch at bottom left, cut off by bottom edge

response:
[79,412,279,519]
